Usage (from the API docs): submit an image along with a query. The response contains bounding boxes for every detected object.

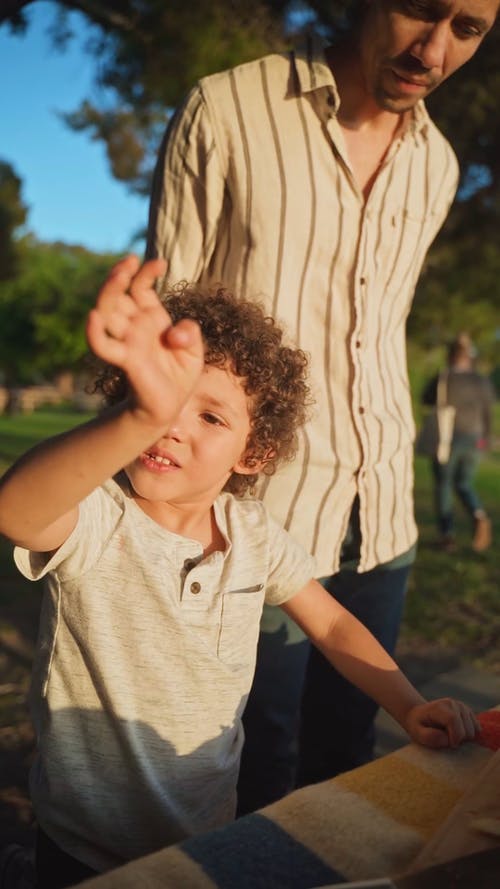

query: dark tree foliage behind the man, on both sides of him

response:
[0,0,500,352]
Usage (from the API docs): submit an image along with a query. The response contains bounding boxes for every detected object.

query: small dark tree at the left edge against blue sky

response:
[0,161,27,280]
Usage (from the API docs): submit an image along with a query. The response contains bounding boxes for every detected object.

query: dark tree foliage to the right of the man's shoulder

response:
[408,27,500,352]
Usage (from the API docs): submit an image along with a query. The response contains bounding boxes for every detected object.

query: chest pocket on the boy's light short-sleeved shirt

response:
[217,583,264,667]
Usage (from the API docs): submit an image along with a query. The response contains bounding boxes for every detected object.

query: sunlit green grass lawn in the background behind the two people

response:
[0,405,500,670]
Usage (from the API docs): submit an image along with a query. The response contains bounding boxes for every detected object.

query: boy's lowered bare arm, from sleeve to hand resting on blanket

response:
[281,580,479,748]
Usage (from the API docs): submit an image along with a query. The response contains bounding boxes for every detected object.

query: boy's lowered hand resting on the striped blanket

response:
[405,698,479,748]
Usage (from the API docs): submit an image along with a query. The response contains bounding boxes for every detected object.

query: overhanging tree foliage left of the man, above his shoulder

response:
[0,0,287,194]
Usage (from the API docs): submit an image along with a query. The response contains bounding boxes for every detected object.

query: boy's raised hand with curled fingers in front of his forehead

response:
[86,256,204,425]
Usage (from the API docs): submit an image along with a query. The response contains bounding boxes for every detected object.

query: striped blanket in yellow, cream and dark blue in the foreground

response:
[81,744,494,889]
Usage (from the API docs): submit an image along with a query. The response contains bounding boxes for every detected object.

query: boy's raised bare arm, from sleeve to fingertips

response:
[0,256,204,552]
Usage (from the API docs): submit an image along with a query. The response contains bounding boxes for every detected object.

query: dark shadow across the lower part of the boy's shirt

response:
[30,691,243,870]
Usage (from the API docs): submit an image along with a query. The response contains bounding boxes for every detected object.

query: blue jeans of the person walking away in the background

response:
[432,435,482,534]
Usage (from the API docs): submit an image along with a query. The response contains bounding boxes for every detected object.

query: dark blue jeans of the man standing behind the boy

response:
[238,564,411,815]
